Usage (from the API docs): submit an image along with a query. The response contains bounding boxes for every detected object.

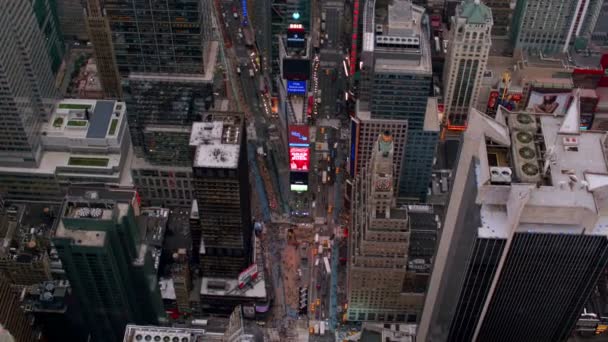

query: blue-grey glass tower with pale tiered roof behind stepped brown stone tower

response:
[351,0,439,200]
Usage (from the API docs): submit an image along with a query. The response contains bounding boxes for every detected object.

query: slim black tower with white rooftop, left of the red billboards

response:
[190,114,253,277]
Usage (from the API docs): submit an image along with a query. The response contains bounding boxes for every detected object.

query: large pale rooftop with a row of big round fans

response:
[461,92,608,237]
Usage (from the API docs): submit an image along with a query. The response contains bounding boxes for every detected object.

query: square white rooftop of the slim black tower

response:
[190,118,242,169]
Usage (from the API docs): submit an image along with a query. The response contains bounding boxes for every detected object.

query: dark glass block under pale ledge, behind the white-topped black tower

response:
[123,73,215,161]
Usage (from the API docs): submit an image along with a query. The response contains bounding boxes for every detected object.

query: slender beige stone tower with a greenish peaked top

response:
[443,0,493,129]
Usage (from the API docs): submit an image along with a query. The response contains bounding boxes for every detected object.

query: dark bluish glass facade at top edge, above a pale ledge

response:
[105,0,211,76]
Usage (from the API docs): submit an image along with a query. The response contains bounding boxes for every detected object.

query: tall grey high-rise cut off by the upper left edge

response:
[0,0,58,166]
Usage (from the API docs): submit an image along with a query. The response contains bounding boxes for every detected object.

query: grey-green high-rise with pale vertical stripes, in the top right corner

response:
[511,0,603,55]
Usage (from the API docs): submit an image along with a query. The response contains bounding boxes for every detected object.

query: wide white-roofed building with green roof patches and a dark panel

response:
[0,99,132,201]
